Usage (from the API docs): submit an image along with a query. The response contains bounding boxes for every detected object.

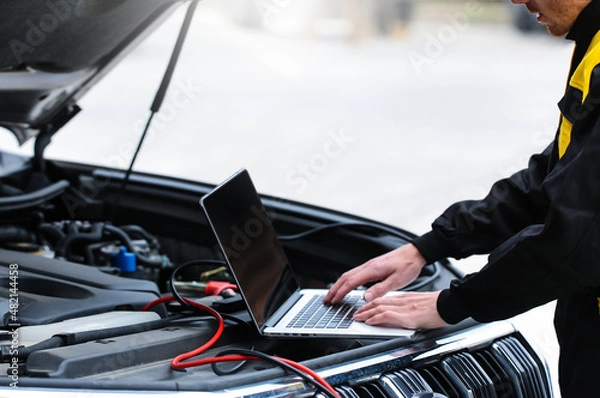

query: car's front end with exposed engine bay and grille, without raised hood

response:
[0,158,550,398]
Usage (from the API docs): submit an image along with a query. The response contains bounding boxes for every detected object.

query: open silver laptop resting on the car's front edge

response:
[200,169,414,338]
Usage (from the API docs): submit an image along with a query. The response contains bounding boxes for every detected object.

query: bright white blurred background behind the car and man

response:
[0,0,572,392]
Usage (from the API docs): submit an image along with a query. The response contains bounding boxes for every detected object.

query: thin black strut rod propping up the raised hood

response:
[110,0,199,222]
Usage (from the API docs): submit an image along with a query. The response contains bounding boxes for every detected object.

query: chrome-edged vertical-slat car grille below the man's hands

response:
[328,336,552,398]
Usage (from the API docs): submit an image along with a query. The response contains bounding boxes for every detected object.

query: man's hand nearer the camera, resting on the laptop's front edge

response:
[354,291,447,329]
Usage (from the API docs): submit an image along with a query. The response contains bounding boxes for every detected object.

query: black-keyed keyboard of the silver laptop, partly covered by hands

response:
[287,295,365,329]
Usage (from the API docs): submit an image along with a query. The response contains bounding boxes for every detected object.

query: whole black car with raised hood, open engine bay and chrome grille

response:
[0,0,553,398]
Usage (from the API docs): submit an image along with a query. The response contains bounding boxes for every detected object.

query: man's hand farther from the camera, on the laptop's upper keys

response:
[323,243,425,304]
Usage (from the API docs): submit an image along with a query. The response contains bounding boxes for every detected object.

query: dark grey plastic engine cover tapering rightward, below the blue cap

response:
[0,249,160,326]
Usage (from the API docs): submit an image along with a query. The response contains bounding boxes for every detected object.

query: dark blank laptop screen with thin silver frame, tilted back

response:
[201,169,299,328]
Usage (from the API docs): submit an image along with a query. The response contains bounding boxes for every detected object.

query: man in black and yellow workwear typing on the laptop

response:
[325,0,600,397]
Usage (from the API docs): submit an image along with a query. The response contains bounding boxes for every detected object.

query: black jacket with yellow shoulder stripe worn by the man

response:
[413,0,600,323]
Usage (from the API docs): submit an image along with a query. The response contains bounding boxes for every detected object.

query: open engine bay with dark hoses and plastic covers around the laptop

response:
[0,158,440,381]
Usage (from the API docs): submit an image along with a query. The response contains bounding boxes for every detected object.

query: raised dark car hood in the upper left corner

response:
[0,0,182,144]
